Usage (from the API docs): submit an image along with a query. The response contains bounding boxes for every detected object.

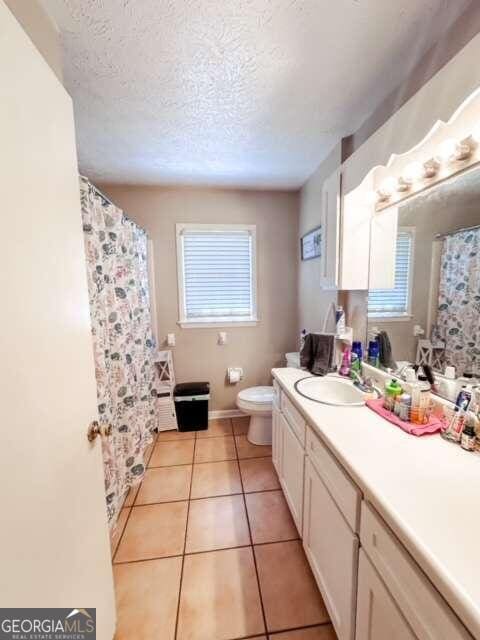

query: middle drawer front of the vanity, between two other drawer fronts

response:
[306,427,362,532]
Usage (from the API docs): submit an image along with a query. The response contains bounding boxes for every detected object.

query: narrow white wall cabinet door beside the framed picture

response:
[320,171,341,289]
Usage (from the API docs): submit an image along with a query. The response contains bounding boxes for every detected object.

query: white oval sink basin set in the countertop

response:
[295,376,365,407]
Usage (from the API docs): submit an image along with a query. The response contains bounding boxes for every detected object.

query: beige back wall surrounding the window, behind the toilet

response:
[100,185,298,410]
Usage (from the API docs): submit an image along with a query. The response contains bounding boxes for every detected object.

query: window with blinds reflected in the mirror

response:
[368,228,414,318]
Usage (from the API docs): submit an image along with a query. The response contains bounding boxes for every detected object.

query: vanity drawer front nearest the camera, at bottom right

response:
[360,502,472,640]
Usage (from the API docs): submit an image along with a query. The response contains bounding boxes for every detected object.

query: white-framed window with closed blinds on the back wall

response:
[177,224,257,327]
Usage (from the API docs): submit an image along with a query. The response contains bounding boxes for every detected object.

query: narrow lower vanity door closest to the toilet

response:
[279,413,305,536]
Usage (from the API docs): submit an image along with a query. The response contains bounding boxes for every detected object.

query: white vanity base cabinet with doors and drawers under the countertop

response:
[272,380,473,640]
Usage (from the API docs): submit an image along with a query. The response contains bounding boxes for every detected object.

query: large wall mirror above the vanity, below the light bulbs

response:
[367,167,480,400]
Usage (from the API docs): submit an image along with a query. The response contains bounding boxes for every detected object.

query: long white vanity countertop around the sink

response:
[272,368,480,639]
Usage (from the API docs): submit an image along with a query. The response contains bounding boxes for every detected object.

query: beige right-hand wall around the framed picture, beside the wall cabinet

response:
[297,144,342,338]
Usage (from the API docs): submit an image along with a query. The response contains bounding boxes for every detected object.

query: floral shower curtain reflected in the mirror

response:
[436,229,480,375]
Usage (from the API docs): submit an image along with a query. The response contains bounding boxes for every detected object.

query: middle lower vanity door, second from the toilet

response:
[303,456,358,640]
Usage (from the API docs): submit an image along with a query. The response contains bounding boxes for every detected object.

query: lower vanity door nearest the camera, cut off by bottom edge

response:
[355,551,416,640]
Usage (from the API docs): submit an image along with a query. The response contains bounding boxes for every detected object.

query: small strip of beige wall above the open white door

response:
[5,0,63,83]
